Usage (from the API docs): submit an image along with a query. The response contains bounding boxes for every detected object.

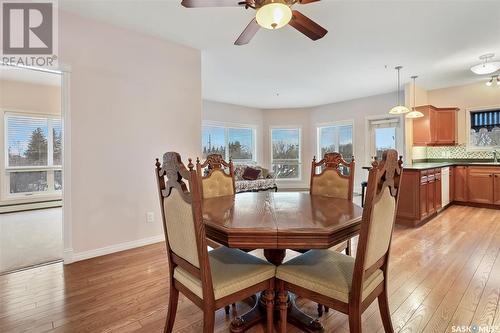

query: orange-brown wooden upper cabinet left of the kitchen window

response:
[413,105,459,146]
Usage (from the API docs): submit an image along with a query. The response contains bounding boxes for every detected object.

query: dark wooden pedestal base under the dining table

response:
[230,249,323,333]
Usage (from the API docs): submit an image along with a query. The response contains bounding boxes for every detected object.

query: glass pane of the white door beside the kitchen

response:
[369,117,403,160]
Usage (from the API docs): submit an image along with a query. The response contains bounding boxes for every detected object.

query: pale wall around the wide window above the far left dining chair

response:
[200,100,264,164]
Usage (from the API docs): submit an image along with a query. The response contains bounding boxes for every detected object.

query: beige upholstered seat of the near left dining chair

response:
[174,247,276,300]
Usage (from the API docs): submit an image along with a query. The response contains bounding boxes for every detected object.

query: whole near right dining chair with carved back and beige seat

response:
[276,149,402,333]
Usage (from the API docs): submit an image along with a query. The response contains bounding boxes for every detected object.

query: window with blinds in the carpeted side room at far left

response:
[5,114,62,195]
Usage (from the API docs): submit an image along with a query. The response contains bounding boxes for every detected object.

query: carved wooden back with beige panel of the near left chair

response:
[155,152,214,300]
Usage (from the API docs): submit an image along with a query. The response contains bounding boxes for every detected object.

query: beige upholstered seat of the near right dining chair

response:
[276,250,384,303]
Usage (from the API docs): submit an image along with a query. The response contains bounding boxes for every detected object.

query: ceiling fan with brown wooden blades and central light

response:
[181,0,328,45]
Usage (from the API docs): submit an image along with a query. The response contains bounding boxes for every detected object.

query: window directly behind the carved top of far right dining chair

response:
[317,123,354,161]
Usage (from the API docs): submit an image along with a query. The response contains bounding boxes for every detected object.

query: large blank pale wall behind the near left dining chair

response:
[59,12,202,258]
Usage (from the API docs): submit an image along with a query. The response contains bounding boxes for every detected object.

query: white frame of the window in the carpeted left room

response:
[2,110,64,200]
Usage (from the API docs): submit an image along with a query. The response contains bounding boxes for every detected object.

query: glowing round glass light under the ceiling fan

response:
[255,0,292,30]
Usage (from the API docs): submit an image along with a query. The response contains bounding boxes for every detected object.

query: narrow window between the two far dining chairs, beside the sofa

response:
[271,128,300,179]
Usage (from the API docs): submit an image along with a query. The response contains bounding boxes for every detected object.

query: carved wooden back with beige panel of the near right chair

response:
[351,149,403,302]
